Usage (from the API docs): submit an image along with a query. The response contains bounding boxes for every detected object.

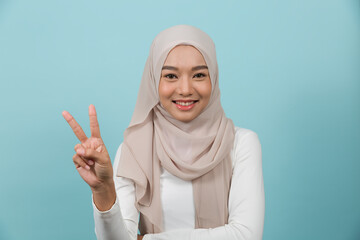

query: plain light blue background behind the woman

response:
[0,0,360,240]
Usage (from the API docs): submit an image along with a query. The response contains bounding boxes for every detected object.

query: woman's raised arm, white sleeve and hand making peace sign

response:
[62,105,137,240]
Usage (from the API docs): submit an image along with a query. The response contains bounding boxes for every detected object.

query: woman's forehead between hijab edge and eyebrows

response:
[164,45,206,67]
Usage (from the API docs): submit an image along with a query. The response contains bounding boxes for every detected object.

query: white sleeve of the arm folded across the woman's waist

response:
[143,129,265,240]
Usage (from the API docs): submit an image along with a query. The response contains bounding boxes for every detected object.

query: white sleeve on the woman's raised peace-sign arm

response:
[92,145,139,240]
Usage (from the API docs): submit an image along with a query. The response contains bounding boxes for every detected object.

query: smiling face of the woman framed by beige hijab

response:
[159,45,211,122]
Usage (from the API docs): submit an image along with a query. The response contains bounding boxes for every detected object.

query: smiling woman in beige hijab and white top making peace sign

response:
[63,25,265,239]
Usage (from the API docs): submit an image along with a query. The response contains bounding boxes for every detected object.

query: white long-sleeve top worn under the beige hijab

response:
[93,127,265,240]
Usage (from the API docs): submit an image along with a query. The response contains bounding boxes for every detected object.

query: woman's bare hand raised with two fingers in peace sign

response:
[62,105,113,192]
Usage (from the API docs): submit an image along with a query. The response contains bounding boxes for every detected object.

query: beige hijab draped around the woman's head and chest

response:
[117,25,234,234]
